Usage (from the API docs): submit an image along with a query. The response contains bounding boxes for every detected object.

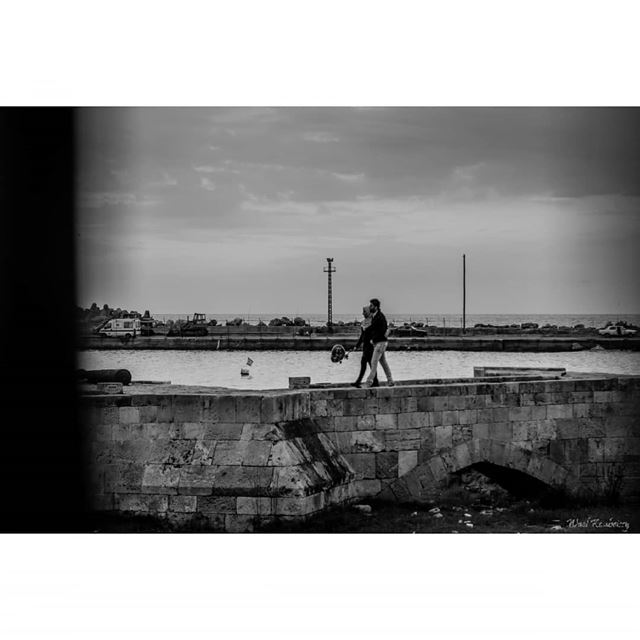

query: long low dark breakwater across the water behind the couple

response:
[78,332,640,352]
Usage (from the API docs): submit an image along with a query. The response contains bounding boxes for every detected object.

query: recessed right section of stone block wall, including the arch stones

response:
[310,377,640,500]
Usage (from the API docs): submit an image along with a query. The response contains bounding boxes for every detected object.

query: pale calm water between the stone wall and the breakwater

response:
[78,350,640,389]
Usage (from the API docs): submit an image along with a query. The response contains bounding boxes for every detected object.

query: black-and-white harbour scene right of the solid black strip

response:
[75,107,640,533]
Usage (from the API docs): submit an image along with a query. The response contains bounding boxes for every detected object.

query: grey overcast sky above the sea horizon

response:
[77,108,640,315]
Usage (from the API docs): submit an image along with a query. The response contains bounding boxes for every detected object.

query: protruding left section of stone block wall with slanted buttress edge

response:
[82,393,356,532]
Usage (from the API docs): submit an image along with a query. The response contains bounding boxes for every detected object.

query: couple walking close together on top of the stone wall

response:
[352,298,393,387]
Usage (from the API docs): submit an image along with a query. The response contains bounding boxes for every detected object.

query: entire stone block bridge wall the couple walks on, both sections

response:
[82,374,640,531]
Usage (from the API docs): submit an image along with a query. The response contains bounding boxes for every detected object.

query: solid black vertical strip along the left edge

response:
[0,108,85,532]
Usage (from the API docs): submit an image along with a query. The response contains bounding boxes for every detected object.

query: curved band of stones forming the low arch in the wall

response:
[377,438,578,502]
